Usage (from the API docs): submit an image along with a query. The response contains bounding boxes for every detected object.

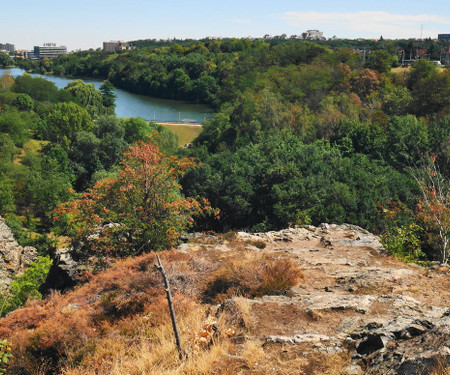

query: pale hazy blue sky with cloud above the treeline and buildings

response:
[0,0,450,50]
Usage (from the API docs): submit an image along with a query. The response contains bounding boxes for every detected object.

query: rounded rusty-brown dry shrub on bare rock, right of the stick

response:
[203,256,303,302]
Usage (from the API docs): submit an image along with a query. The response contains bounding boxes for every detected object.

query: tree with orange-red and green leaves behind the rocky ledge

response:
[54,142,216,256]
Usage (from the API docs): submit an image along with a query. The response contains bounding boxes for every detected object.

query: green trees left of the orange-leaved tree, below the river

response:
[0,73,178,242]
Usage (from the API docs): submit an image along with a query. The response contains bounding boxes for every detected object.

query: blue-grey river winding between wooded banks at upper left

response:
[0,68,213,124]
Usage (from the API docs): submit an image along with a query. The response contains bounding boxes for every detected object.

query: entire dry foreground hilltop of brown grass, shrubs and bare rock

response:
[0,224,450,375]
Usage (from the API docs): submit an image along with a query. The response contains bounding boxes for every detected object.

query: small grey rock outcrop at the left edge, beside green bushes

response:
[0,216,37,289]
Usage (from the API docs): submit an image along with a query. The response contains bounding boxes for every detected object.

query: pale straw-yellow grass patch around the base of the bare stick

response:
[61,298,234,375]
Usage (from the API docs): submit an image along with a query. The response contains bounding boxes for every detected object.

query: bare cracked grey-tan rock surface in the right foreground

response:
[238,224,450,375]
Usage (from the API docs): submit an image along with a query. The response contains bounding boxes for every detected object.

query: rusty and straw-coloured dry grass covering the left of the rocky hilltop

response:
[0,244,302,375]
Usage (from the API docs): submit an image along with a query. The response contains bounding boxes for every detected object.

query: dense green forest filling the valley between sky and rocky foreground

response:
[0,38,450,314]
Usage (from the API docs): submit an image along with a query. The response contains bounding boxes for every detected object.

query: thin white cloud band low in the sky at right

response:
[282,11,450,38]
